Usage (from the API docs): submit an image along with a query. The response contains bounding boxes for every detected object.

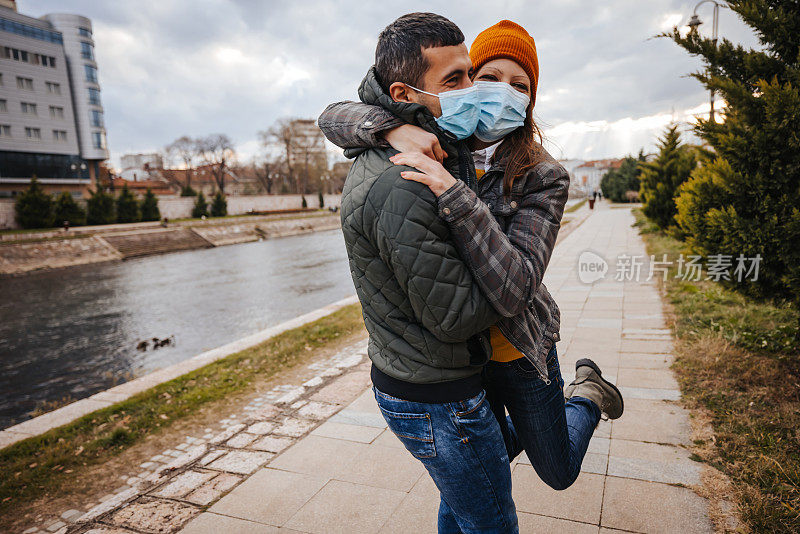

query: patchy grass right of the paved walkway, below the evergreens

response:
[634,210,800,533]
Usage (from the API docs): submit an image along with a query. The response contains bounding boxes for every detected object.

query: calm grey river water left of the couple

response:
[0,230,355,429]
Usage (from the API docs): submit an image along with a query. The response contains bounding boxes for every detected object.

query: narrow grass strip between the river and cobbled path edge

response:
[0,304,364,520]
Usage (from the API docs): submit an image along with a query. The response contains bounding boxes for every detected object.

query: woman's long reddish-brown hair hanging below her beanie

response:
[492,104,544,197]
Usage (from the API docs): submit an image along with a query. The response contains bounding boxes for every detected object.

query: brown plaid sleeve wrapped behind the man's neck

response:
[317,101,405,148]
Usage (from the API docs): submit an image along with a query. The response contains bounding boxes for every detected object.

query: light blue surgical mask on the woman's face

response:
[473,81,531,143]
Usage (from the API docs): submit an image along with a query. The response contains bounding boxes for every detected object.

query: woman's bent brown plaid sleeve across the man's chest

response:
[437,161,569,317]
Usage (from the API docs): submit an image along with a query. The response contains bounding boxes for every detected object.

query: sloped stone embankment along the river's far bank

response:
[0,213,340,274]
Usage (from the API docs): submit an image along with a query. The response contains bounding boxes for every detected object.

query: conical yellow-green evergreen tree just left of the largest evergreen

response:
[639,124,697,232]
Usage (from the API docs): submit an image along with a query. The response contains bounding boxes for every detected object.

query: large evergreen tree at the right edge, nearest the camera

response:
[668,0,800,305]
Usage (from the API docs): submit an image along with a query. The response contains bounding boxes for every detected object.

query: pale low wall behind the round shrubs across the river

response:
[0,194,342,230]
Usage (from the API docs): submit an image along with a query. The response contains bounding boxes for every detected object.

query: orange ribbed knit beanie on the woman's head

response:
[469,20,539,102]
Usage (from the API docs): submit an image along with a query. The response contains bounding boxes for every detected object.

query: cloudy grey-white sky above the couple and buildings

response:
[18,0,756,168]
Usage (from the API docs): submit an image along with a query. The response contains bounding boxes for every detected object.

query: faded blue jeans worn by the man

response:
[373,387,519,534]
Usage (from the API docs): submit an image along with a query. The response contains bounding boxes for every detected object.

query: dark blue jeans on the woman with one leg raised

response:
[483,345,600,490]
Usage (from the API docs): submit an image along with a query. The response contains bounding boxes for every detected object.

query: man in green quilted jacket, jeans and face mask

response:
[334,13,518,533]
